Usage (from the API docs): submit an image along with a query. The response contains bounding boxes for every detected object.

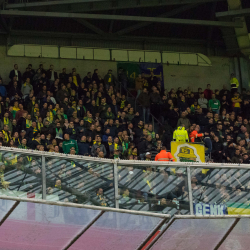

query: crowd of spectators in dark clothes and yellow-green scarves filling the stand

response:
[0,64,247,163]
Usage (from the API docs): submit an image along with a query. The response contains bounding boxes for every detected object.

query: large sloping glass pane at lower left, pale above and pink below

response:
[0,202,101,250]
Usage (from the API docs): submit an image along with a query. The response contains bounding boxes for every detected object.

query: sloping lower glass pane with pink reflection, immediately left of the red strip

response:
[69,212,162,250]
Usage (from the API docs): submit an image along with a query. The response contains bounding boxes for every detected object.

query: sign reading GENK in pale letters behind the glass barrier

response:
[194,203,227,215]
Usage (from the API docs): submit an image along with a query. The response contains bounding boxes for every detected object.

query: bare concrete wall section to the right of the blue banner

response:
[163,57,234,91]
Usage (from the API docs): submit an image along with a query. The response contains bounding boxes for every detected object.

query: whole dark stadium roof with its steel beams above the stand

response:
[0,0,247,53]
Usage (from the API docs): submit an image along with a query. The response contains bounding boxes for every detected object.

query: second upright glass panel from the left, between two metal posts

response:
[45,157,115,207]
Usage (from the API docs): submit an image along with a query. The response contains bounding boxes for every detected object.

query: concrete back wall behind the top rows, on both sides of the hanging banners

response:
[0,46,234,91]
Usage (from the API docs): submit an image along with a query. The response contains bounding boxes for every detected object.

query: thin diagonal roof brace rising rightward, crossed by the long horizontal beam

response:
[116,4,200,35]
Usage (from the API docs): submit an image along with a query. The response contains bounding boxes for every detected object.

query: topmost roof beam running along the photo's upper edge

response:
[4,0,225,12]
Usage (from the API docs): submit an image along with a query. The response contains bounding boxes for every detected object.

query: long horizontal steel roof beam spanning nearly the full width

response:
[0,10,243,28]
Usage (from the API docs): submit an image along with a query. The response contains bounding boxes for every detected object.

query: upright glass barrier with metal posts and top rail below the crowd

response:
[0,147,250,215]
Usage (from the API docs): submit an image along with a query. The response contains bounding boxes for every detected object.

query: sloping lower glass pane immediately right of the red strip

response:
[150,219,236,250]
